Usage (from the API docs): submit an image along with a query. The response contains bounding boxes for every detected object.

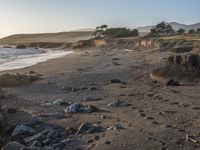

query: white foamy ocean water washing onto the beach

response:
[0,48,73,71]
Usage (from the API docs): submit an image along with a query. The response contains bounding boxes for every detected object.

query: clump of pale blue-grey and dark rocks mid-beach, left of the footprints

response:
[64,103,99,114]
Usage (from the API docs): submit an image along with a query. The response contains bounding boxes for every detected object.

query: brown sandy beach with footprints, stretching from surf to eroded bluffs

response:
[0,46,200,150]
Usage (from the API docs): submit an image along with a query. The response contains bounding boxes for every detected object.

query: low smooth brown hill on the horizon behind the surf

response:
[0,30,93,45]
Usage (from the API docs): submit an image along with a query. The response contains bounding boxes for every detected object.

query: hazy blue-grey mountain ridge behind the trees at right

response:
[137,22,200,33]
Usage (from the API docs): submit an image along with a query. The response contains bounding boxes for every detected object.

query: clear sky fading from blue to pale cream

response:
[0,0,200,37]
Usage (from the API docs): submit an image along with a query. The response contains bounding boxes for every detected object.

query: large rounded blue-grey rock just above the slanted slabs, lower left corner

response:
[12,125,35,138]
